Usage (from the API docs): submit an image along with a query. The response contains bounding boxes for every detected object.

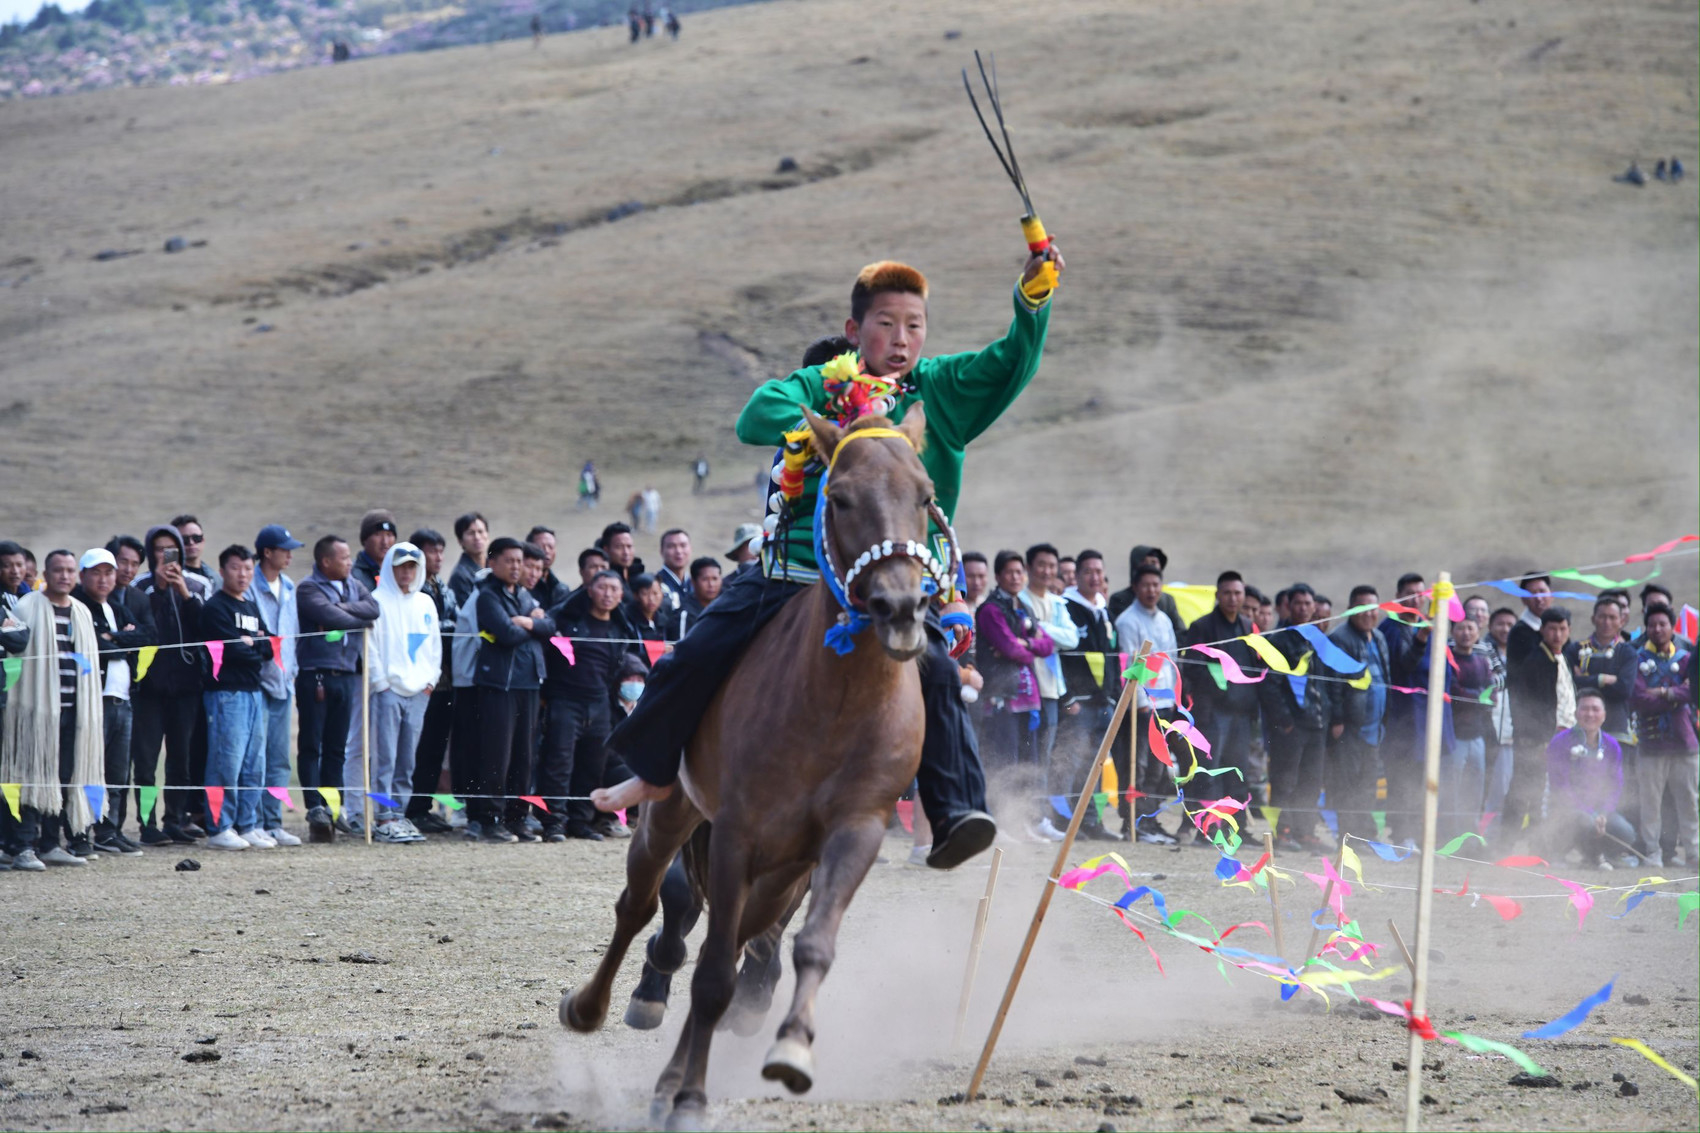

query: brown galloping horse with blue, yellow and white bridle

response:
[561,403,935,1130]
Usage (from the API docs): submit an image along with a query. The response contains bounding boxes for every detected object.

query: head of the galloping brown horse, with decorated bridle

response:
[804,401,933,660]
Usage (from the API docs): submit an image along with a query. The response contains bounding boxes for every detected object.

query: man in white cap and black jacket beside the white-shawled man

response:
[71,548,153,856]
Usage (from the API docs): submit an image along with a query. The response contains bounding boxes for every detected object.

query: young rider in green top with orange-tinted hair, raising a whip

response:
[592,247,1063,869]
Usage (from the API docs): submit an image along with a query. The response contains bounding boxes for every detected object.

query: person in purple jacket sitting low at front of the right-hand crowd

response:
[1547,689,1641,869]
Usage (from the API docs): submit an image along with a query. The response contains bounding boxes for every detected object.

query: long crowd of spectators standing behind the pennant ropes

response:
[0,510,1700,871]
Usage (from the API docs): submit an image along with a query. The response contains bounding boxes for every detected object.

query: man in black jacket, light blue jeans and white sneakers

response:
[201,543,277,851]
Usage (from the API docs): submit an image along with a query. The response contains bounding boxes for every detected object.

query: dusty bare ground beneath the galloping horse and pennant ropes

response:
[0,819,1700,1130]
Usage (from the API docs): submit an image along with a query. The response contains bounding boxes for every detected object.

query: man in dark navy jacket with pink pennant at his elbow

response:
[462,538,554,842]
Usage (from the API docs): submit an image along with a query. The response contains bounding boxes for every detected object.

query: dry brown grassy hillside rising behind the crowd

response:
[0,0,1700,597]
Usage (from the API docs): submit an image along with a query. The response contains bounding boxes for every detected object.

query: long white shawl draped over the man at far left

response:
[0,590,105,819]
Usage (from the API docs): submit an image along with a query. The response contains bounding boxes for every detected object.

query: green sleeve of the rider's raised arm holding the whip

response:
[921,280,1051,451]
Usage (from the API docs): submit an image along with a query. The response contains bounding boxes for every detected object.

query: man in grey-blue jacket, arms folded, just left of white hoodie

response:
[296,534,377,842]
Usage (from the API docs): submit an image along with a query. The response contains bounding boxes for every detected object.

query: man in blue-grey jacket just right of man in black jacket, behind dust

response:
[1328,585,1392,839]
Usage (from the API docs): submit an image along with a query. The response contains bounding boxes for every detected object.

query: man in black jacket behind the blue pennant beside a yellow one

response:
[1258,582,1333,852]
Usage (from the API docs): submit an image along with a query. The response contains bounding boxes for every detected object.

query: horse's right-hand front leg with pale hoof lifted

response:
[762,817,886,1094]
